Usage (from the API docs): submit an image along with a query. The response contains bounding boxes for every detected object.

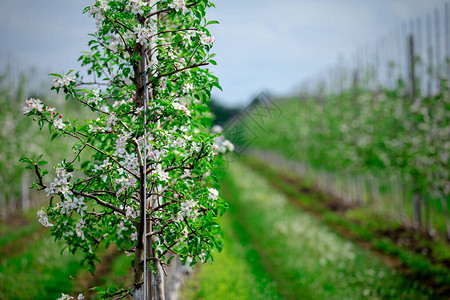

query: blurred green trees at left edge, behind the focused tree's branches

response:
[0,72,86,217]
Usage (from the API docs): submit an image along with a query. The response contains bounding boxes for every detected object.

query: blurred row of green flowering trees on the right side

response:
[234,82,450,202]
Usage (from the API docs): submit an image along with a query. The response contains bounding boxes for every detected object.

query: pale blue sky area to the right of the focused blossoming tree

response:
[210,0,444,103]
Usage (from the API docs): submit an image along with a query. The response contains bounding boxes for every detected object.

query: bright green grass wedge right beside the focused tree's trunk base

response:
[182,214,282,300]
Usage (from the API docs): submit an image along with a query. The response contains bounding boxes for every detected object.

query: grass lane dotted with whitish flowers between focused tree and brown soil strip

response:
[212,163,436,299]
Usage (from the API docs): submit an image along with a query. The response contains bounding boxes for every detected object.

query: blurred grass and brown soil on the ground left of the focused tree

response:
[0,211,133,300]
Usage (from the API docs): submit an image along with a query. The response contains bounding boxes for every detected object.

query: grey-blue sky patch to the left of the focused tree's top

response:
[0,0,94,71]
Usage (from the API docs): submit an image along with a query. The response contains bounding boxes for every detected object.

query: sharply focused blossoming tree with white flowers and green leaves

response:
[22,0,225,296]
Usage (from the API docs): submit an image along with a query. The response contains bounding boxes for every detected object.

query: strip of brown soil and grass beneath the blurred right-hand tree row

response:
[244,152,450,299]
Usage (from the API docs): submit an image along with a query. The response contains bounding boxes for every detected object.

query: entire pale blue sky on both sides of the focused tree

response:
[0,0,448,106]
